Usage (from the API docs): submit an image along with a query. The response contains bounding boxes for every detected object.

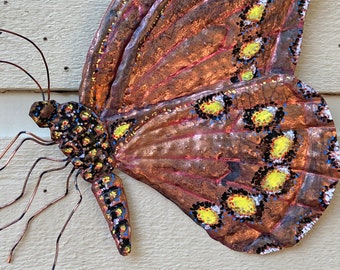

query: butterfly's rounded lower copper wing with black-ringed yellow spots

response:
[111,75,340,253]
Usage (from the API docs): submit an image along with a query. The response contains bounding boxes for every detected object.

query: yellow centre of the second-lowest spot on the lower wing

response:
[227,194,256,216]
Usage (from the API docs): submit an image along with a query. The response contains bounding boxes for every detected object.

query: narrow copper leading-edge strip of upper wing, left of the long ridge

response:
[79,0,159,114]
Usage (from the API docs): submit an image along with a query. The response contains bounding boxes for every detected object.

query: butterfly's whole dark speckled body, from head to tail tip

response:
[30,101,131,255]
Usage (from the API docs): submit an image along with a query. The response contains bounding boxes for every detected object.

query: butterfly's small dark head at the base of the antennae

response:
[29,100,58,128]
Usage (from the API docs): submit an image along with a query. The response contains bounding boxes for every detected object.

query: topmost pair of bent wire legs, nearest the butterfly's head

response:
[0,131,55,171]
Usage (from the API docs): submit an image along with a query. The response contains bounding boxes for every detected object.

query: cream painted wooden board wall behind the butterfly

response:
[0,0,340,270]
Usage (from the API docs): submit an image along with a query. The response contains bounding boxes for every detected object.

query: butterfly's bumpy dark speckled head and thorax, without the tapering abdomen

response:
[30,101,115,182]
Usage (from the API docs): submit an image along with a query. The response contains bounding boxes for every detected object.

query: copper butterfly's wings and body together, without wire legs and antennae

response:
[0,0,340,268]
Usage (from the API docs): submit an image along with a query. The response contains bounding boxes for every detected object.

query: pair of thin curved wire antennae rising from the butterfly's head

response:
[0,28,51,100]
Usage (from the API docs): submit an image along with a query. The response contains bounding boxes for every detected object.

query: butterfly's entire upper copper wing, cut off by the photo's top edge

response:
[80,0,308,118]
